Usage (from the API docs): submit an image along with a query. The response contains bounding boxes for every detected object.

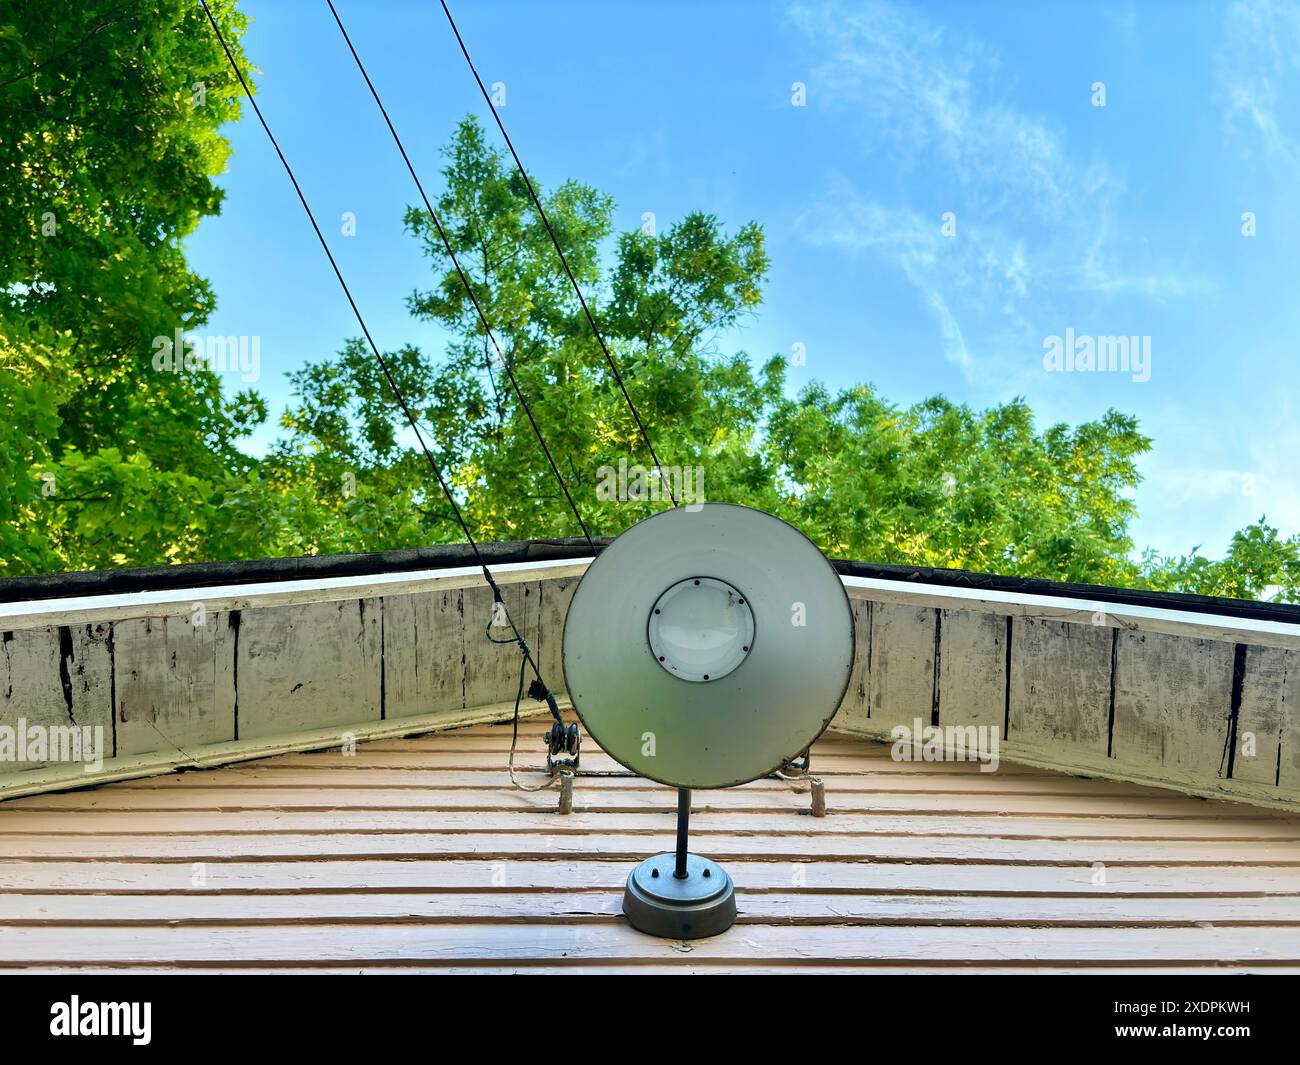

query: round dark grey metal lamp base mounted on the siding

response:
[623,854,736,939]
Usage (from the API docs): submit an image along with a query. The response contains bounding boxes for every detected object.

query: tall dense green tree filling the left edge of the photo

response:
[0,0,259,573]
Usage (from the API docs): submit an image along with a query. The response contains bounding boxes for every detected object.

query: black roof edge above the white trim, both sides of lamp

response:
[0,537,1300,624]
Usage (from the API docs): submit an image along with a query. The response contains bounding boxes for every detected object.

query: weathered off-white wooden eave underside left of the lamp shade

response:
[0,563,559,795]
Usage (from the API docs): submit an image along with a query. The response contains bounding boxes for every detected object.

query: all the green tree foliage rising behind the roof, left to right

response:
[0,37,1300,599]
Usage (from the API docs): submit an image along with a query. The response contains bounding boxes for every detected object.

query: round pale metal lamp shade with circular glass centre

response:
[564,503,854,788]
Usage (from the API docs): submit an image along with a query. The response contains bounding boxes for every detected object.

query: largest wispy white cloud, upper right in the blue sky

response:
[789,3,1208,380]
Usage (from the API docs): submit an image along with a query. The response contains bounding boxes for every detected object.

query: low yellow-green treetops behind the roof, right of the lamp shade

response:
[767,385,1149,584]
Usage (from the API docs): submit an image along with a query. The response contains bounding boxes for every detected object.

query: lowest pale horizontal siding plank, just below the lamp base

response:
[0,922,1300,969]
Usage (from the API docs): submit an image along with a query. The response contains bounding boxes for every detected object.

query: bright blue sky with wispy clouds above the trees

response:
[189,0,1300,555]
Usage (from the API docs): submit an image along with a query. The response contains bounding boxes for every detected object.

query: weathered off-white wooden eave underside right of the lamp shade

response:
[835,579,1300,810]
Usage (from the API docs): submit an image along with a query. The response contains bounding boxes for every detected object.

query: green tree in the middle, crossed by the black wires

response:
[264,120,780,542]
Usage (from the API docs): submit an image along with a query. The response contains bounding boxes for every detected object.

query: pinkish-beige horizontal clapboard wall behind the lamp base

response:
[0,719,1300,973]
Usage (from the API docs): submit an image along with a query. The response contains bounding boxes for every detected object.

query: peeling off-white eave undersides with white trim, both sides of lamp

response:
[0,559,1300,809]
